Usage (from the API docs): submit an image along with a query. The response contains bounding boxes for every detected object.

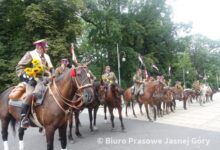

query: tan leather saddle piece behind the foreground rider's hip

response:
[8,82,26,101]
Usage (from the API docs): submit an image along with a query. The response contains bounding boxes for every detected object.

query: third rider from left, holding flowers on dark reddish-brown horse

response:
[102,65,118,85]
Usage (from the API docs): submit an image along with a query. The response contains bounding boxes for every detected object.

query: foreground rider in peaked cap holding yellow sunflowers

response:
[16,39,54,128]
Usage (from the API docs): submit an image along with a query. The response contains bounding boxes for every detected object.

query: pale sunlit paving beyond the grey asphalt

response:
[93,93,220,132]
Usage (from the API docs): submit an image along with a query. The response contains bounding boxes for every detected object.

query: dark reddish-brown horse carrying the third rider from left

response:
[104,83,125,131]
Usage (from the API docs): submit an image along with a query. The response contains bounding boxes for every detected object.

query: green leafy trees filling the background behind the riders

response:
[0,0,220,90]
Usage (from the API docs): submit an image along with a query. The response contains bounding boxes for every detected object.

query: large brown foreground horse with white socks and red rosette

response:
[0,65,93,150]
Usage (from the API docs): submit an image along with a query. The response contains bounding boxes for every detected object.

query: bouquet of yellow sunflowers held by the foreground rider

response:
[24,59,44,78]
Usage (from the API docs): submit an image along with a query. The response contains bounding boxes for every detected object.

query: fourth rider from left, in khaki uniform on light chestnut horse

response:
[133,68,144,100]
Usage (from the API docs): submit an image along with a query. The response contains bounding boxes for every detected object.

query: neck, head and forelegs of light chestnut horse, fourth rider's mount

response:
[138,81,164,121]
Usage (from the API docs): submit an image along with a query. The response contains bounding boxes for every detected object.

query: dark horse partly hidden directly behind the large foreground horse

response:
[68,81,106,141]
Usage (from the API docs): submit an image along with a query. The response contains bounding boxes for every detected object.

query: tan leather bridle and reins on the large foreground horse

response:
[49,66,92,113]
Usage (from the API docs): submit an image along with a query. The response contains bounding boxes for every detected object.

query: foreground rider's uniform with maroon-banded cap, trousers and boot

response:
[16,40,53,128]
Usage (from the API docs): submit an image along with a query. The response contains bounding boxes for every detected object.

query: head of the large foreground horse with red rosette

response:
[71,65,94,105]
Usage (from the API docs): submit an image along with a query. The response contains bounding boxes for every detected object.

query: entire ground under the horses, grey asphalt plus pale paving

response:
[0,94,220,150]
